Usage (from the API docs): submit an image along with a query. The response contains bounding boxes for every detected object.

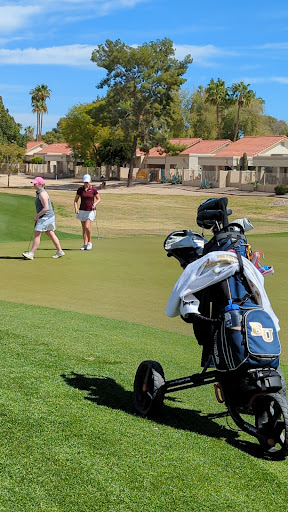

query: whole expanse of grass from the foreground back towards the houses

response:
[0,192,288,512]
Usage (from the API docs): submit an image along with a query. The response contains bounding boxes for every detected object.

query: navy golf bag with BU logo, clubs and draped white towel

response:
[164,197,281,373]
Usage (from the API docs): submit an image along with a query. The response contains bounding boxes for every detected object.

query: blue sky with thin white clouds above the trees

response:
[0,0,288,133]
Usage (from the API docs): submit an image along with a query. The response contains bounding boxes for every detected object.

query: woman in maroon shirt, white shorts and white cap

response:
[74,174,100,251]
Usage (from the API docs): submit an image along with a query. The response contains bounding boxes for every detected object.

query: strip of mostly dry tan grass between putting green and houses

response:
[0,186,288,240]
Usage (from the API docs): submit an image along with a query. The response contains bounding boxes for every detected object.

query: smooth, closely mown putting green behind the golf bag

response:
[0,236,288,362]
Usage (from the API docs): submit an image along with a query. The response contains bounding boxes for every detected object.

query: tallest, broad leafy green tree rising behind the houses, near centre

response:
[91,38,192,187]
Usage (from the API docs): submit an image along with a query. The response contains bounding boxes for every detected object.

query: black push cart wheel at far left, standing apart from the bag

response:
[133,361,165,417]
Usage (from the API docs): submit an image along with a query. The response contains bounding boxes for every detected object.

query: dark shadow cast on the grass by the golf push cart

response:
[61,372,238,444]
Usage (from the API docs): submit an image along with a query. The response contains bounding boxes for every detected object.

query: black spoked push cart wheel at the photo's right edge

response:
[254,393,288,458]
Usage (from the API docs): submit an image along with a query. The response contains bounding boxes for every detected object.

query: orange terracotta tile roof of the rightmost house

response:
[215,135,288,157]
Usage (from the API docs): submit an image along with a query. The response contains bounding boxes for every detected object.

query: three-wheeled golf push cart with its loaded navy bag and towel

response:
[133,197,288,458]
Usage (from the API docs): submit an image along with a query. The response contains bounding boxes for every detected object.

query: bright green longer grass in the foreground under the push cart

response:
[0,302,288,512]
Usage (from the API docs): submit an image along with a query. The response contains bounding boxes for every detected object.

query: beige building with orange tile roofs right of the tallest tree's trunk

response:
[135,135,288,186]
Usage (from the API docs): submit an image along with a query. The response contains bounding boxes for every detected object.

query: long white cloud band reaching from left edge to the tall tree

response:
[0,44,96,68]
